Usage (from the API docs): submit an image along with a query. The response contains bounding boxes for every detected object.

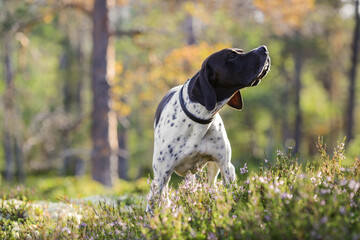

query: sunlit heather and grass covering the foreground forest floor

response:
[0,140,360,240]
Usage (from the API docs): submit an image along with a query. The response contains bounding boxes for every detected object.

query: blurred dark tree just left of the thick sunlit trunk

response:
[59,11,87,175]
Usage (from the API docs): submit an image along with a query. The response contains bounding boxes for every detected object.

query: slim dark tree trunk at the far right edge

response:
[345,0,360,143]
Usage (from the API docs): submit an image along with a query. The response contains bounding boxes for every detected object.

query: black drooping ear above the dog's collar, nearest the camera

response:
[189,61,217,111]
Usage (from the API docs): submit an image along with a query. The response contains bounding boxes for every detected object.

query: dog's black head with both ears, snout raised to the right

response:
[189,46,270,111]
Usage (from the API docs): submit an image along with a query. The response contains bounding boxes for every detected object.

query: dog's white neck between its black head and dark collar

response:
[182,80,228,122]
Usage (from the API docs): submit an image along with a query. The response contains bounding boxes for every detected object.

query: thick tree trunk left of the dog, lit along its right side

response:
[91,0,112,186]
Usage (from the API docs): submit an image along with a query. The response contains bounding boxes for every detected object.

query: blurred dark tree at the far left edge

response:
[0,1,31,181]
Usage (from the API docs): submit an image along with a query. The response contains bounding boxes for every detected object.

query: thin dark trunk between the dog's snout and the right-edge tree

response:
[294,36,303,154]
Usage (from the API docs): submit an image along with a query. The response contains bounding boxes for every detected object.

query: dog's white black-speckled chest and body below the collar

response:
[154,94,226,172]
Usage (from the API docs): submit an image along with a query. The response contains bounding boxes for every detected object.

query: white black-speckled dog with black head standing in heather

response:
[147,46,270,210]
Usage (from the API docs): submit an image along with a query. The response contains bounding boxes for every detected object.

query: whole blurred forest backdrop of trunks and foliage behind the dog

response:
[0,0,360,186]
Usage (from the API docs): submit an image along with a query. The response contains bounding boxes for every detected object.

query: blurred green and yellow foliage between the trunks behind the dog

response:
[0,0,360,179]
